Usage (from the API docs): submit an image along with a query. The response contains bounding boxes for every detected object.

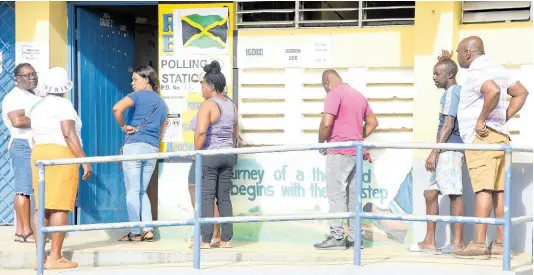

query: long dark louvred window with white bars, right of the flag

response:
[237,1,415,29]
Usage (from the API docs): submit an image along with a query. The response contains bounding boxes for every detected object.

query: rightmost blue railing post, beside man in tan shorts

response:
[502,146,512,271]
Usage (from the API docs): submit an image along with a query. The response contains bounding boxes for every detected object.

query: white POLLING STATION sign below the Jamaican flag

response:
[159,55,232,97]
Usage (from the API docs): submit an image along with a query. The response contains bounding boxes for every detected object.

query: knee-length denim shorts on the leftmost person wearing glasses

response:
[9,139,33,195]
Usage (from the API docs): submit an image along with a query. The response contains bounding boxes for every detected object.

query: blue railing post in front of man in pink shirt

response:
[353,144,363,265]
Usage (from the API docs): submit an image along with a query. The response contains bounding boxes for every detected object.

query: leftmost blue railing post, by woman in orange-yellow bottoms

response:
[37,164,45,275]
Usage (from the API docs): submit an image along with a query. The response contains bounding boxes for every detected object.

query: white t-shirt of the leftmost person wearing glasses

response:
[2,87,40,148]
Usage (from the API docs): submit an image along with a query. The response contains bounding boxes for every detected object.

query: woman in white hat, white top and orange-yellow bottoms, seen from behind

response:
[26,68,91,269]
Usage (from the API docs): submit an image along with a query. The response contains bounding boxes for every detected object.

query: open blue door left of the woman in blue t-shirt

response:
[76,8,135,224]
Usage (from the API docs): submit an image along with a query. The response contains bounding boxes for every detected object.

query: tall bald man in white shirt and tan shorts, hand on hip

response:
[455,36,528,259]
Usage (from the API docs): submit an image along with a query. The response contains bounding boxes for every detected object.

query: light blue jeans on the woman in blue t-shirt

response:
[122,143,158,234]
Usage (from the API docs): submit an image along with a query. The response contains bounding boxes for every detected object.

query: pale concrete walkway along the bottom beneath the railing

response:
[0,228,532,275]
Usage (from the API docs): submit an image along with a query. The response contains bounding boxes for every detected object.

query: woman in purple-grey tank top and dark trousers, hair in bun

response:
[195,61,238,248]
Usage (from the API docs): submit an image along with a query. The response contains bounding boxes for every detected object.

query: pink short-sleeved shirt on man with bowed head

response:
[324,84,373,155]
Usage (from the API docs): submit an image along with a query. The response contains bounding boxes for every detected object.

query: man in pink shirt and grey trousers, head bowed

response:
[314,70,378,249]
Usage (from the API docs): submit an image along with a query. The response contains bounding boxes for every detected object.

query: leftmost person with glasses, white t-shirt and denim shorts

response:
[2,63,39,242]
